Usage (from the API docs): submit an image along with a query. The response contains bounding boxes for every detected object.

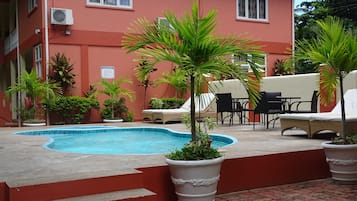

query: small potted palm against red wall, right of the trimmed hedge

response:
[98,78,133,123]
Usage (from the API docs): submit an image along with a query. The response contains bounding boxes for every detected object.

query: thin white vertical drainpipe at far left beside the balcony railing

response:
[15,0,21,127]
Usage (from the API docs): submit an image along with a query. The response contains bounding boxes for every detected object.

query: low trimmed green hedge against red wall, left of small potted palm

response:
[44,96,99,124]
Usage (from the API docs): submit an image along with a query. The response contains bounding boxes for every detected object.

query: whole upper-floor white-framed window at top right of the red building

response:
[237,0,268,20]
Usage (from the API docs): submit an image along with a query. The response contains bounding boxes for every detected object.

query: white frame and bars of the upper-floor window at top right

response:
[236,0,269,22]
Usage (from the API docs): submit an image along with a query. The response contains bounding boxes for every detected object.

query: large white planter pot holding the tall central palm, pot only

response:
[166,157,224,201]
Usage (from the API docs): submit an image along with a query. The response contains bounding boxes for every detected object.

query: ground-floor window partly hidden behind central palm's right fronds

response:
[232,54,266,72]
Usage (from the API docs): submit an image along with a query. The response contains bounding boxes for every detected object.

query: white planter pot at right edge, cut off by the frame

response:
[321,142,357,183]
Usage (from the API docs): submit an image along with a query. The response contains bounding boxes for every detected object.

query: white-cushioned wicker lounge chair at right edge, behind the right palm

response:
[279,89,357,137]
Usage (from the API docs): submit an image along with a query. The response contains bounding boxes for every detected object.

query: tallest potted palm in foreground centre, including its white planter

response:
[123,3,259,201]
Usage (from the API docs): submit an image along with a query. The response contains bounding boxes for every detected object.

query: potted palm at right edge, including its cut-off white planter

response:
[298,17,357,182]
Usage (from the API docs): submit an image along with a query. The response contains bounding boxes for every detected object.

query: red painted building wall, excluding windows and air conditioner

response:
[0,0,293,123]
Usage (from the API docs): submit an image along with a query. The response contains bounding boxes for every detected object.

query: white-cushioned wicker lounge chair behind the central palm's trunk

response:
[142,93,216,124]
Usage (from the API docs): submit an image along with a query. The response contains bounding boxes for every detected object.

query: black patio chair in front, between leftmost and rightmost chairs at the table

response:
[253,91,283,129]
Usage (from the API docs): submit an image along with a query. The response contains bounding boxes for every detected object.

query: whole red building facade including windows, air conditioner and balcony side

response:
[0,0,294,125]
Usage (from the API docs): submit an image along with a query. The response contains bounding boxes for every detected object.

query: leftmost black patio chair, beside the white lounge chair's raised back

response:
[216,93,242,125]
